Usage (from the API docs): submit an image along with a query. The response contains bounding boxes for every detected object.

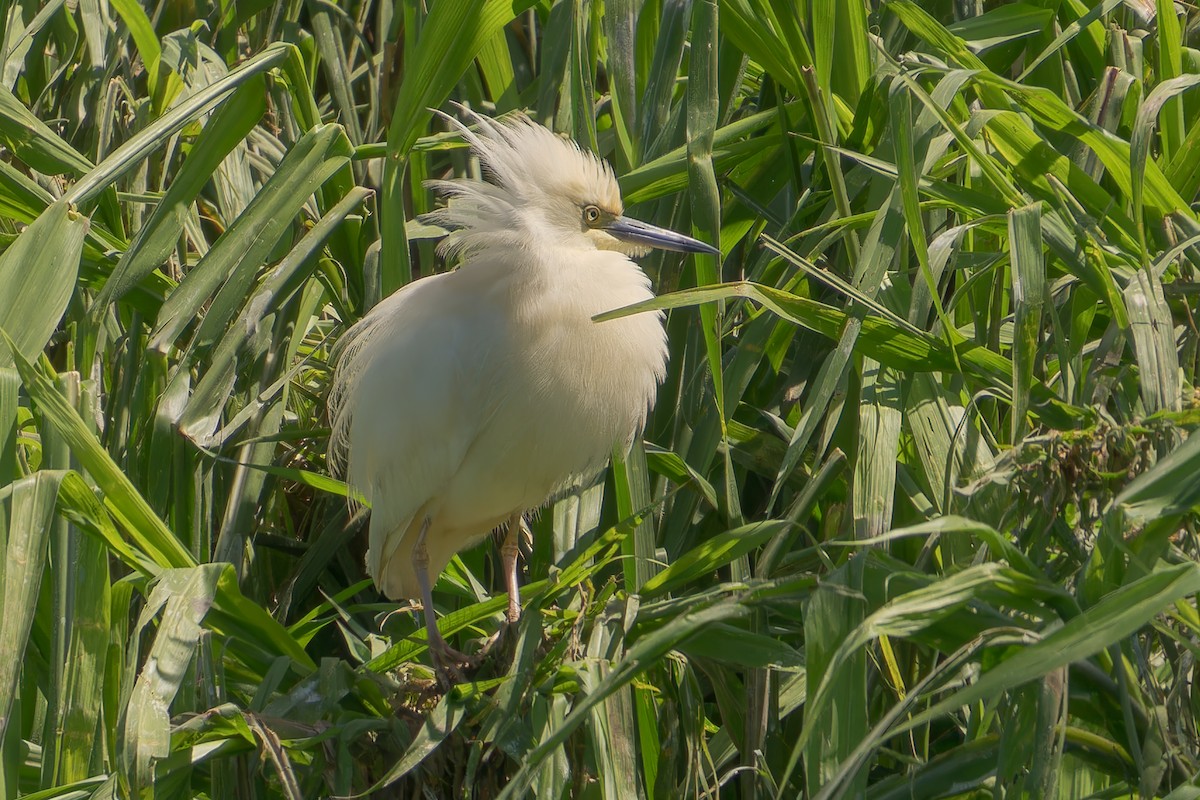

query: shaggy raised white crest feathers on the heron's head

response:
[422,109,622,260]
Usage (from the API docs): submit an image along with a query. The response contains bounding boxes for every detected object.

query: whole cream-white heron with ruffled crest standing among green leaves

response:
[329,114,719,674]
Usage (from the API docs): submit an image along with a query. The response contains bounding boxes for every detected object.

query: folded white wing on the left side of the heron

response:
[331,272,502,596]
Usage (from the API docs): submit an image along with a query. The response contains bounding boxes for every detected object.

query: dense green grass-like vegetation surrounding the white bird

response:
[0,0,1200,800]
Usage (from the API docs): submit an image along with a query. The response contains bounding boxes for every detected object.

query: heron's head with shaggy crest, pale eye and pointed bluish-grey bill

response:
[430,106,720,261]
